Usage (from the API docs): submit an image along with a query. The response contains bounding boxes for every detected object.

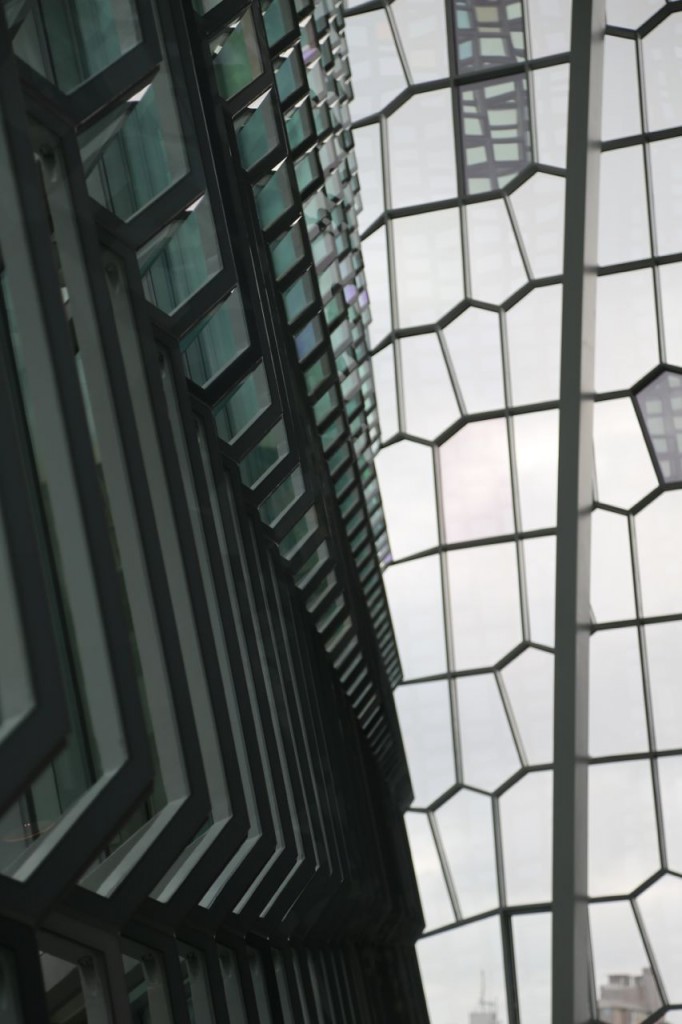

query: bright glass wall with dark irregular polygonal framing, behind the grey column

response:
[344,0,682,1024]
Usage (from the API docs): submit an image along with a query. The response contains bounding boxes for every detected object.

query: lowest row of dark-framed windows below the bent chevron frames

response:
[0,927,425,1024]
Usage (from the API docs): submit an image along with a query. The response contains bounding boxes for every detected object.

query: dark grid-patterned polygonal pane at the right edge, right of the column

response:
[636,370,682,483]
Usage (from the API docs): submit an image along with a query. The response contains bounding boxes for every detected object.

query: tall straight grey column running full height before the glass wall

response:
[552,0,605,1024]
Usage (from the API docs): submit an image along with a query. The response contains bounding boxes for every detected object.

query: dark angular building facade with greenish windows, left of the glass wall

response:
[0,0,426,1024]
